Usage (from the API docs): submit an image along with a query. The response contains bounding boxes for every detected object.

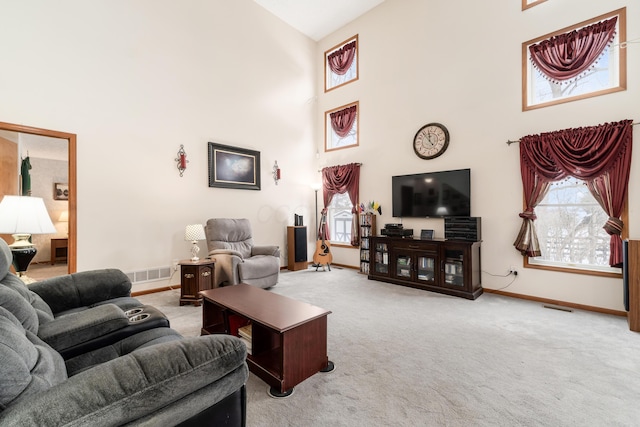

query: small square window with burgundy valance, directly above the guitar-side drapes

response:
[324,101,360,151]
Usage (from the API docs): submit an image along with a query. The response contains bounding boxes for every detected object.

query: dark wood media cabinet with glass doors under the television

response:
[369,237,482,299]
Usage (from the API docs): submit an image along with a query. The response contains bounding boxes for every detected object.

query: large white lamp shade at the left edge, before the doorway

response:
[0,196,57,234]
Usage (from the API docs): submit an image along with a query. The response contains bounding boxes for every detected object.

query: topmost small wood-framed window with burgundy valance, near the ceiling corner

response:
[324,34,358,92]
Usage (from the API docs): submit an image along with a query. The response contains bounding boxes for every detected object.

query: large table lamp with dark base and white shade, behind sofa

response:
[0,196,57,283]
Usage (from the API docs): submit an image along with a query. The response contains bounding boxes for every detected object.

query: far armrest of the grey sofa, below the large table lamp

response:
[29,269,131,314]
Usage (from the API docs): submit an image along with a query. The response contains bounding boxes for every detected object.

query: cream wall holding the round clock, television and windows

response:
[316,0,640,310]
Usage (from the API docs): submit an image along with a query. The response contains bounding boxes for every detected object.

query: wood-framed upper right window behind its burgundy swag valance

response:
[522,8,626,111]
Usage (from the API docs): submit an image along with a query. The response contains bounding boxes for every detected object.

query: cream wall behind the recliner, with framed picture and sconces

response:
[0,0,316,287]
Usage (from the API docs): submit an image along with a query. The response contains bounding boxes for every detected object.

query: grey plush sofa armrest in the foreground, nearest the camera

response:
[0,335,248,426]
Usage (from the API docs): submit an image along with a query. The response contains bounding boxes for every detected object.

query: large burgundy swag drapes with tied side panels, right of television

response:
[514,120,632,267]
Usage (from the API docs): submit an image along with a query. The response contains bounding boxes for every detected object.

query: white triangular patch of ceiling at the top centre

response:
[253,0,384,41]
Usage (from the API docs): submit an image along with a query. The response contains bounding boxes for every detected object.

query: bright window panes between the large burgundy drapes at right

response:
[528,178,620,273]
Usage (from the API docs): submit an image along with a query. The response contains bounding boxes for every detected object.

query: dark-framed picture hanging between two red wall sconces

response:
[209,142,260,190]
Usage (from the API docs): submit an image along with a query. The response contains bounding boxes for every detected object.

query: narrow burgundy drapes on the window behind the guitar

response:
[318,163,360,246]
